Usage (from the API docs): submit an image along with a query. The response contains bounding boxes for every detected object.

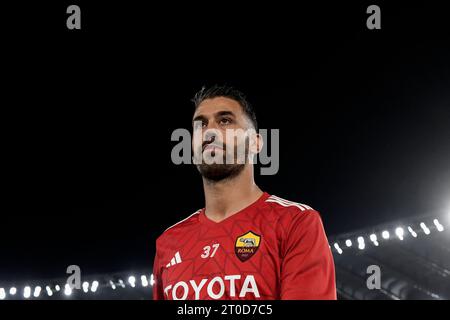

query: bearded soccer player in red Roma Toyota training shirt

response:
[153,86,336,300]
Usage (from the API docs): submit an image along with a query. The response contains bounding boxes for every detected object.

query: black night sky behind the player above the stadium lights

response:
[0,2,450,280]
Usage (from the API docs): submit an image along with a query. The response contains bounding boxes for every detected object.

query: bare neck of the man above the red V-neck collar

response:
[203,168,263,222]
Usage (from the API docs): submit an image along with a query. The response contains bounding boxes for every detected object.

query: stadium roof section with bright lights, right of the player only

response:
[331,217,450,300]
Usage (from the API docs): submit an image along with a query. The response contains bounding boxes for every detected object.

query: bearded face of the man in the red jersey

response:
[192,97,253,181]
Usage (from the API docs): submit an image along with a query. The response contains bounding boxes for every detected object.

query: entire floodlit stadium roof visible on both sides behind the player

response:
[0,217,450,300]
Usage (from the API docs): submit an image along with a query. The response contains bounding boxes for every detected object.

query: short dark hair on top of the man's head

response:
[192,85,258,130]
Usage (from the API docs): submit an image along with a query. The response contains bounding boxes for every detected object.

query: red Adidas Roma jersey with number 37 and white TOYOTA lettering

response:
[153,193,336,300]
